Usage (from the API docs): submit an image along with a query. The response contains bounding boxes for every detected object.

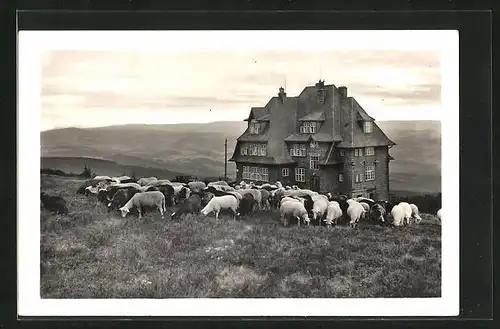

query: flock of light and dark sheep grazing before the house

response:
[41,176,441,227]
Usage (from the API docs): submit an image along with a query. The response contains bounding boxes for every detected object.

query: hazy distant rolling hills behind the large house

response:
[41,121,441,192]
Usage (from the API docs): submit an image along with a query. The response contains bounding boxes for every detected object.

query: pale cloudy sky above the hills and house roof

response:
[41,50,442,130]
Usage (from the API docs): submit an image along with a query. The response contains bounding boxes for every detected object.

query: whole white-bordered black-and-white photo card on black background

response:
[18,30,459,316]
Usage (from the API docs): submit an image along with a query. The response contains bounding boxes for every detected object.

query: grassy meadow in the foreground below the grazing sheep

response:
[40,176,441,298]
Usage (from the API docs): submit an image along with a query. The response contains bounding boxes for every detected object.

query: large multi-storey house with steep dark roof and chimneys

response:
[229,80,396,200]
